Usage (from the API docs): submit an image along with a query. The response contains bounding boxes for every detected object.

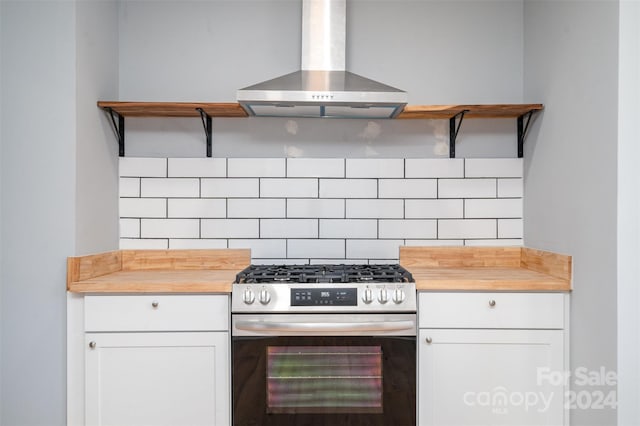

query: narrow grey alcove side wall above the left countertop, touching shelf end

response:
[75,1,118,254]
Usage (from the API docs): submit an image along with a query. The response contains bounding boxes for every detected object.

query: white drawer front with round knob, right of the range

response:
[418,292,565,329]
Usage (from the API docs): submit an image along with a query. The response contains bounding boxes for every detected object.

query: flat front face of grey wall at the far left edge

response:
[0,1,76,425]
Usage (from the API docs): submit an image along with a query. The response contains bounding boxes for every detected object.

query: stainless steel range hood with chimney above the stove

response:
[237,0,407,119]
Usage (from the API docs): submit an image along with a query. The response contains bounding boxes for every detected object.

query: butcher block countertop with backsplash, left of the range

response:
[67,249,251,293]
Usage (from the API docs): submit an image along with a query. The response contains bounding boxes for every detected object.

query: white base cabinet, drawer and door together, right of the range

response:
[418,292,568,426]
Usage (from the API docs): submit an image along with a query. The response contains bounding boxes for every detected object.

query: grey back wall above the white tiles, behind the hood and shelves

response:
[120,0,523,158]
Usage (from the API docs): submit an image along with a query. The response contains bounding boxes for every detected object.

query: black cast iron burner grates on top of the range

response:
[235,264,414,284]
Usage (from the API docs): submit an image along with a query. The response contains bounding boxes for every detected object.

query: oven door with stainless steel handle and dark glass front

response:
[232,314,416,426]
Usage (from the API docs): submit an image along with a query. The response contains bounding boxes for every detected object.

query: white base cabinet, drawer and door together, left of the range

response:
[75,295,231,426]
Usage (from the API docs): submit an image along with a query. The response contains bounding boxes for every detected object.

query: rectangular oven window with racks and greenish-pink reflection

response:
[266,346,383,413]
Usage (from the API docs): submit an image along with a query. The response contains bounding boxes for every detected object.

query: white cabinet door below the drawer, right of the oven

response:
[418,329,564,426]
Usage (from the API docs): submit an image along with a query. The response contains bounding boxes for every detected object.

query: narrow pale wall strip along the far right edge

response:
[618,1,640,425]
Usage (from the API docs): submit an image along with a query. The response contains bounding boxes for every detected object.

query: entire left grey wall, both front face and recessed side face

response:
[0,0,118,426]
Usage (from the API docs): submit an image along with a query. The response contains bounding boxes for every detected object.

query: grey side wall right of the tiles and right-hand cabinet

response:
[524,0,618,425]
